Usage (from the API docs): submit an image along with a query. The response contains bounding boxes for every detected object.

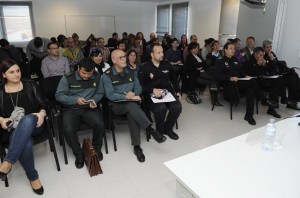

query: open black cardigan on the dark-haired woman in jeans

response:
[0,80,47,115]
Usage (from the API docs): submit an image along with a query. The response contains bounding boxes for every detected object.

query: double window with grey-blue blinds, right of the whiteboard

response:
[156,2,188,39]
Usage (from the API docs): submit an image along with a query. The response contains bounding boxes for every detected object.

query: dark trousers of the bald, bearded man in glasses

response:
[112,102,151,146]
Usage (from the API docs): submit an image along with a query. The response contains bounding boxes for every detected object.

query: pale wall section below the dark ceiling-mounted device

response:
[237,0,278,46]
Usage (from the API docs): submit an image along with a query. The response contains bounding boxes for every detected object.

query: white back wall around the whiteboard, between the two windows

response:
[32,0,156,39]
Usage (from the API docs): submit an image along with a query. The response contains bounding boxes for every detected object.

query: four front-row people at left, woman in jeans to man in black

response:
[0,44,182,194]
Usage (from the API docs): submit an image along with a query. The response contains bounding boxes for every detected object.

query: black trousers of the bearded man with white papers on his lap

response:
[150,100,182,133]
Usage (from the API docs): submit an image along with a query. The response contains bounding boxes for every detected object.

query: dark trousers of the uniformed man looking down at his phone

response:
[62,108,105,157]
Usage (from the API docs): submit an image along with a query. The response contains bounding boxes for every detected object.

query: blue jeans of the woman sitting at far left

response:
[4,114,44,181]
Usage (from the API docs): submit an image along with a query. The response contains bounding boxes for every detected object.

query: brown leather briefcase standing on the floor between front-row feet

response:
[82,138,103,177]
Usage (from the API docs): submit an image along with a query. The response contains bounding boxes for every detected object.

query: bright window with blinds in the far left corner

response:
[0,2,33,42]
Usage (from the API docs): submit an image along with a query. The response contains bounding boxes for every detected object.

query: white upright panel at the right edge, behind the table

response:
[277,0,300,68]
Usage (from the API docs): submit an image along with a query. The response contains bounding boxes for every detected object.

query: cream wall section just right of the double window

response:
[160,0,222,47]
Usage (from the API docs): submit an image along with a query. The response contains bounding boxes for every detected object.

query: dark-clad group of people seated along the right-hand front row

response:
[184,41,299,125]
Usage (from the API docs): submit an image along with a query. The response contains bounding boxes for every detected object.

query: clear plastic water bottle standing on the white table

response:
[262,118,276,151]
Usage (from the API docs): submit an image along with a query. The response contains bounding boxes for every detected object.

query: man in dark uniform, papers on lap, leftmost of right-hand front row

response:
[215,43,276,125]
